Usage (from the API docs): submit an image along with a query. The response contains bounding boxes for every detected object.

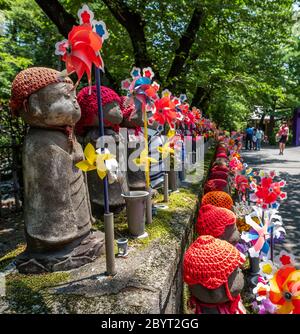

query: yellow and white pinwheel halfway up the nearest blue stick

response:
[75,143,115,179]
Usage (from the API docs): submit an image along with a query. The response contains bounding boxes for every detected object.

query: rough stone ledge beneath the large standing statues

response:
[0,145,213,314]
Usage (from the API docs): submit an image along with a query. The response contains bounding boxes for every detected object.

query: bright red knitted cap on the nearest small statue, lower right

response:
[183,235,245,289]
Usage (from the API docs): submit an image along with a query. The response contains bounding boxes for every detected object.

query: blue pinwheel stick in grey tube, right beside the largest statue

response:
[95,66,116,275]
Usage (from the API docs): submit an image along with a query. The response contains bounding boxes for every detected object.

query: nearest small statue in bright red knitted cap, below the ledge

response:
[183,235,245,314]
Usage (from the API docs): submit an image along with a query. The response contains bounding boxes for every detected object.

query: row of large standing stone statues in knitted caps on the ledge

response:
[10,67,150,273]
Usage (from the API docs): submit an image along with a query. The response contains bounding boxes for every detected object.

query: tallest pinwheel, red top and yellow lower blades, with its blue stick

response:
[55,5,116,275]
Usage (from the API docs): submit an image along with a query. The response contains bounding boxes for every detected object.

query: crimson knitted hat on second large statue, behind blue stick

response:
[75,85,121,135]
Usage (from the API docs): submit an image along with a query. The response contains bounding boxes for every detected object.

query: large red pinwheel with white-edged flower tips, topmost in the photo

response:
[55,5,108,87]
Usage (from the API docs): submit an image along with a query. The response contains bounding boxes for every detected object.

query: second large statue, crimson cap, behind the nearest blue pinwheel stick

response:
[75,86,128,217]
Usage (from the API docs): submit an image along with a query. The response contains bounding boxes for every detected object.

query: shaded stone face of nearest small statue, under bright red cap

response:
[190,268,244,304]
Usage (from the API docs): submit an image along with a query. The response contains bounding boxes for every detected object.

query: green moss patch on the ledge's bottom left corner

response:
[6,272,70,313]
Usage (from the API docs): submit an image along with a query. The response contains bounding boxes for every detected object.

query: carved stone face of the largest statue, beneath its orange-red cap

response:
[20,82,81,128]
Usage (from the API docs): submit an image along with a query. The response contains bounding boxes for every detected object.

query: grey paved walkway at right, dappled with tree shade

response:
[242,147,300,264]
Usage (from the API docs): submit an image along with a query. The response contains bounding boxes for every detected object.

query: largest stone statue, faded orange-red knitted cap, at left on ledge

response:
[11,67,104,273]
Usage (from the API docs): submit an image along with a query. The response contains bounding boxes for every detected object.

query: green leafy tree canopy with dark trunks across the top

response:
[0,0,300,128]
